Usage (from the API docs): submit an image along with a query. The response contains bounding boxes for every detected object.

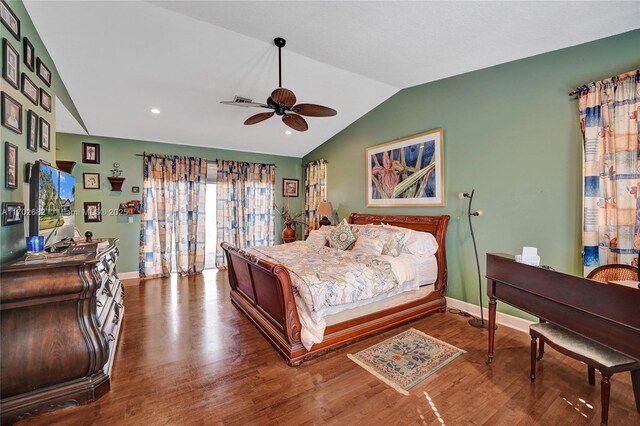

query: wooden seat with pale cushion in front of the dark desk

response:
[529,322,640,425]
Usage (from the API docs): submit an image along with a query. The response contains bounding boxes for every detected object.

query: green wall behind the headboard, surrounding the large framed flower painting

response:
[303,30,640,315]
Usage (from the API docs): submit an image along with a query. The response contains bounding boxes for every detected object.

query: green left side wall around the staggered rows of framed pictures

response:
[0,1,82,263]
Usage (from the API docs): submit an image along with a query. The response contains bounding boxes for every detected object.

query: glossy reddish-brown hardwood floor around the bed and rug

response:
[20,271,640,425]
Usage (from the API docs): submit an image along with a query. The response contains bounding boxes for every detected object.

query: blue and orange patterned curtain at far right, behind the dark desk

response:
[579,70,640,275]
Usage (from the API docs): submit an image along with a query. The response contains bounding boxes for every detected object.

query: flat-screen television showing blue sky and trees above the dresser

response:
[29,161,76,247]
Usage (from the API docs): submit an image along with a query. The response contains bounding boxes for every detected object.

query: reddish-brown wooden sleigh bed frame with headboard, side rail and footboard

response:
[221,213,449,366]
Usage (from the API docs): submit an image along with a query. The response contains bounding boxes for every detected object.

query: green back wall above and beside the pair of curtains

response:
[57,133,304,272]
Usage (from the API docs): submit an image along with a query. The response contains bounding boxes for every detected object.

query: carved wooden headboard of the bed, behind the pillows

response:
[349,213,450,296]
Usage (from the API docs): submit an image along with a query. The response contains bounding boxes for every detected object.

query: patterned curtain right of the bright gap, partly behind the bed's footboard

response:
[216,160,276,269]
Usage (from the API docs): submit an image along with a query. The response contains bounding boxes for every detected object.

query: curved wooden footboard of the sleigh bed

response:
[221,242,306,366]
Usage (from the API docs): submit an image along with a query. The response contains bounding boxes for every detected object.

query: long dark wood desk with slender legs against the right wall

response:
[486,253,640,364]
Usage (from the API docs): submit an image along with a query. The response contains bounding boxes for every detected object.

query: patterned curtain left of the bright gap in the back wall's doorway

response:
[140,153,207,279]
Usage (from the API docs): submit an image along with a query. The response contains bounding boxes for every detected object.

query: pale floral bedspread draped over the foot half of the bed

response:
[245,241,399,321]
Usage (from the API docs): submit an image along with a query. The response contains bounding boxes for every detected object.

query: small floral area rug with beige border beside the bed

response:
[347,328,465,395]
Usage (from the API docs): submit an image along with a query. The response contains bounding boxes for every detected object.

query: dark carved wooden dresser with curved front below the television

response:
[0,239,124,424]
